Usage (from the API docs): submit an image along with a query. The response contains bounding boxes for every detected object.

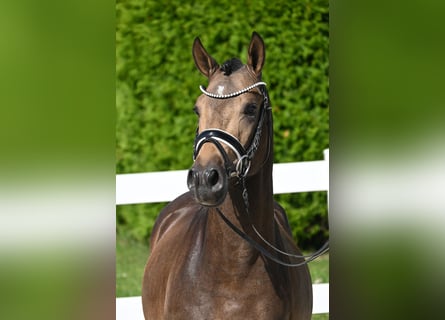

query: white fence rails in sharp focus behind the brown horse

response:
[116,149,329,320]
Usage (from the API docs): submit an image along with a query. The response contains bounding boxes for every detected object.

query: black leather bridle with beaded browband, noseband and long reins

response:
[193,82,329,267]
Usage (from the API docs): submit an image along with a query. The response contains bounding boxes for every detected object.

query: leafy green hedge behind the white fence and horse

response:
[116,0,329,248]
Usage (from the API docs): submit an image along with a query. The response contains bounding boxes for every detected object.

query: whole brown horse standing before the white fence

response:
[142,32,312,320]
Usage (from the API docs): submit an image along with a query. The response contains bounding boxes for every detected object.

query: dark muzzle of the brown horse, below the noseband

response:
[187,163,228,207]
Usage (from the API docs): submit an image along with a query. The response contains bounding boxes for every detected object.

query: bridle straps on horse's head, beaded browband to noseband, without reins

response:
[193,82,270,178]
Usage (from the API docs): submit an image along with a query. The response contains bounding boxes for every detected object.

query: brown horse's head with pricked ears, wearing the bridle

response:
[187,32,269,207]
